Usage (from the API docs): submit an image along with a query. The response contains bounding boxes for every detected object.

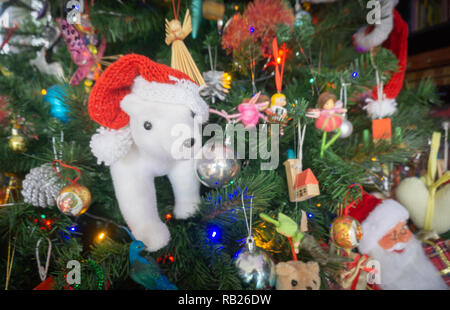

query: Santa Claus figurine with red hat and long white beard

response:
[349,193,447,290]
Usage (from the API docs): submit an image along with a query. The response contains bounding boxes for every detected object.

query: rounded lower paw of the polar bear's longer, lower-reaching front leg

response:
[135,222,170,252]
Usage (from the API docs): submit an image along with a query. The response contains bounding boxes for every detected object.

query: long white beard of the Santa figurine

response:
[367,236,447,290]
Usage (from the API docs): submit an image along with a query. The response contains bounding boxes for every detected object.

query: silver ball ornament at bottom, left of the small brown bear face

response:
[233,241,276,289]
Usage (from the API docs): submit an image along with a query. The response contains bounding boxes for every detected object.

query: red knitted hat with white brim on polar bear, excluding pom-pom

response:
[89,54,208,129]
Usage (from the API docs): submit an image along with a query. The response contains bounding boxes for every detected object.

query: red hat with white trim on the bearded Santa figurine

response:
[348,192,409,254]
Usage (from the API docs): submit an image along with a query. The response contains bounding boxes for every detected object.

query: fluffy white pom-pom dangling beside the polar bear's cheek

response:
[89,126,133,166]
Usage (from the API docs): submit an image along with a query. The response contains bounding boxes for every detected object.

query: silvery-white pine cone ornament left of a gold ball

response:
[22,164,64,208]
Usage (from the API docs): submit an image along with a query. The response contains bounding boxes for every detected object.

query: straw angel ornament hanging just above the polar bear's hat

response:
[166,10,205,85]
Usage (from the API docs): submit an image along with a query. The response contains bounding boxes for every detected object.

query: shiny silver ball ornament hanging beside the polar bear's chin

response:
[195,142,241,188]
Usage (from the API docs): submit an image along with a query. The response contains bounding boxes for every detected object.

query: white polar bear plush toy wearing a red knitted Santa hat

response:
[89,54,208,251]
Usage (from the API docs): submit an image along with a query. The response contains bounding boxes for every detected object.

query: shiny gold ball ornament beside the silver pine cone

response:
[56,184,92,216]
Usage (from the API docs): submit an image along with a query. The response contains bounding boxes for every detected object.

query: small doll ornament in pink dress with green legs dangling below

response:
[306,92,347,157]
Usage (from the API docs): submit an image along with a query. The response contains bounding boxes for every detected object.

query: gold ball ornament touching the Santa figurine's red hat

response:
[330,215,363,249]
